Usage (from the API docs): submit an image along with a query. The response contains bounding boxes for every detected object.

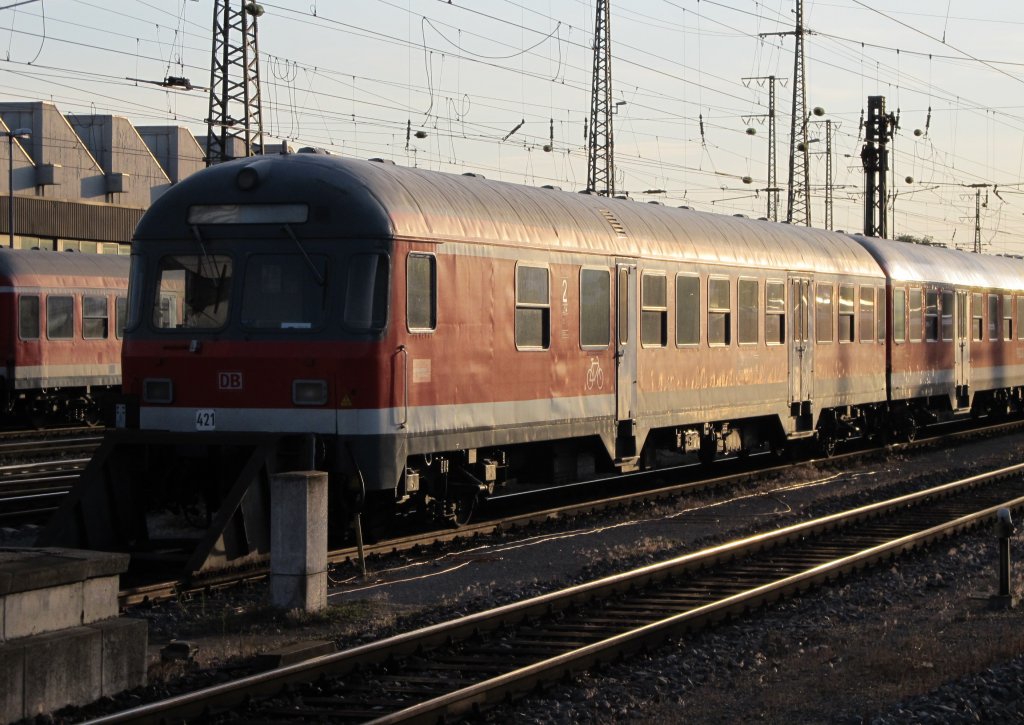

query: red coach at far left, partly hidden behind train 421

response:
[0,248,129,427]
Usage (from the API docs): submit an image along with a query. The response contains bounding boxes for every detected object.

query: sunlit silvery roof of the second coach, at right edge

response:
[854,236,1024,291]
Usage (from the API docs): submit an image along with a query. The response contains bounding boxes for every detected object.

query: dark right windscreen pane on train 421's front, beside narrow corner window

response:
[242,254,330,330]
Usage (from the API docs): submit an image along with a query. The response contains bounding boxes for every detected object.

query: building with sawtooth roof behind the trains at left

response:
[0,101,218,254]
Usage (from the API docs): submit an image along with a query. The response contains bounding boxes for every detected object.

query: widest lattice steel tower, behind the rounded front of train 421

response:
[206,0,263,166]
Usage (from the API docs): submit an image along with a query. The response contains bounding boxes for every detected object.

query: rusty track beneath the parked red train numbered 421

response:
[120,413,1024,607]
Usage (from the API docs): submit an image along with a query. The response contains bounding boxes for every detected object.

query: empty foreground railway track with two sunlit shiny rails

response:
[90,464,1024,723]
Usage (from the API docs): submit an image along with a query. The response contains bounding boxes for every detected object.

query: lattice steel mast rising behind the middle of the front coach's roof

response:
[587,0,615,197]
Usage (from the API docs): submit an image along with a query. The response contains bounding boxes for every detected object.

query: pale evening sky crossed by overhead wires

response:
[0,0,1024,254]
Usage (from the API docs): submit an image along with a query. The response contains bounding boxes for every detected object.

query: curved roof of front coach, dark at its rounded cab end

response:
[135,154,881,278]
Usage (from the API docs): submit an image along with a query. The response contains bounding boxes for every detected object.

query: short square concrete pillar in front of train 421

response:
[270,471,327,611]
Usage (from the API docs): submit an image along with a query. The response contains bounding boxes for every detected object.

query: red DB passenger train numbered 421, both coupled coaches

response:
[120,154,1024,528]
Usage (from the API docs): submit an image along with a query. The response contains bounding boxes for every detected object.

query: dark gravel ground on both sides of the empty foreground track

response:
[49,428,1024,724]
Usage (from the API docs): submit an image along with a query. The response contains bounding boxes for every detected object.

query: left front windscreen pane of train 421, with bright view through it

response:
[153,254,231,330]
